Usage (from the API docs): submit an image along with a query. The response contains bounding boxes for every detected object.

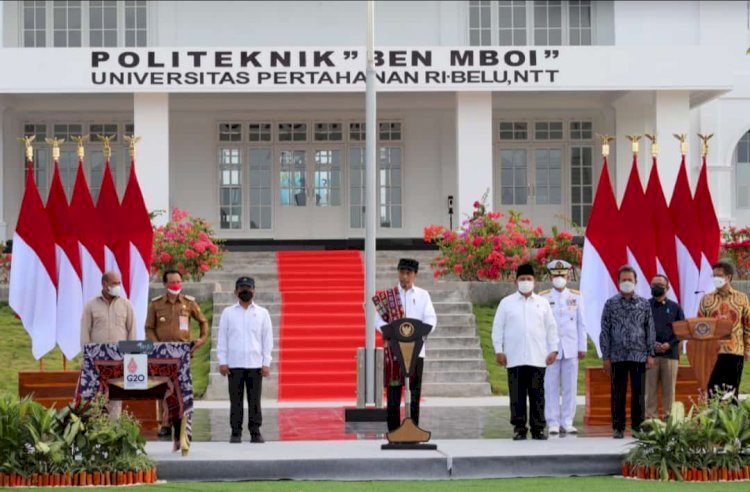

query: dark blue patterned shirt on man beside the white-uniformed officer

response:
[599,294,656,362]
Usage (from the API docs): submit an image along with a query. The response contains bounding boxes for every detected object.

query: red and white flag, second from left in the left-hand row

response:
[47,163,83,359]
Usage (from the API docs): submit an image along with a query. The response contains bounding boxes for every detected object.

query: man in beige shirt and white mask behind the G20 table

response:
[81,272,135,418]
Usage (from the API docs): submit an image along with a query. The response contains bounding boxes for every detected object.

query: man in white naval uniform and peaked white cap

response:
[539,260,586,434]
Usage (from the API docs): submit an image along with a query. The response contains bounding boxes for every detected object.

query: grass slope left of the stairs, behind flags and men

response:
[0,301,213,397]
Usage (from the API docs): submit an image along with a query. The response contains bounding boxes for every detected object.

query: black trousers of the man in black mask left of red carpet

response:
[227,368,263,436]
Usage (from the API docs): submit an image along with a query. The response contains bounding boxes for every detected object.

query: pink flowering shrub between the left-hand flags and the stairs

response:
[151,208,224,282]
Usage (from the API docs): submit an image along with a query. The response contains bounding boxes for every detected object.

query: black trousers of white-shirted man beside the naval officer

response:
[508,366,547,434]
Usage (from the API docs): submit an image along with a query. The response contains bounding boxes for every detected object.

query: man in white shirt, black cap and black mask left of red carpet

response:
[216,277,273,443]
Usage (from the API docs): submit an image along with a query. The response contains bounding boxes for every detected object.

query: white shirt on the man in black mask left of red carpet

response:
[216,302,273,369]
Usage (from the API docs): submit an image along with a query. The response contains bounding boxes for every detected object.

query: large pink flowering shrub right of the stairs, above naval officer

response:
[424,198,542,280]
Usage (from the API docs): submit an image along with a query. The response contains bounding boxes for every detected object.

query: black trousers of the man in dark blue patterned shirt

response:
[611,361,646,431]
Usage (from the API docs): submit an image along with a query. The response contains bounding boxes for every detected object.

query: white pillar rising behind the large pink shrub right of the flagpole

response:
[454,92,493,221]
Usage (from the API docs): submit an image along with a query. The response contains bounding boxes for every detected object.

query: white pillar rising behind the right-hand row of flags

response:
[654,91,700,202]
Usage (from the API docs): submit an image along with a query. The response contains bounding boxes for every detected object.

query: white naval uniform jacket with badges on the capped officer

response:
[539,288,587,359]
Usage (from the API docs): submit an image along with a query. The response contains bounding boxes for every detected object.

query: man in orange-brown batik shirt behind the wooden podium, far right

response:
[698,261,750,397]
